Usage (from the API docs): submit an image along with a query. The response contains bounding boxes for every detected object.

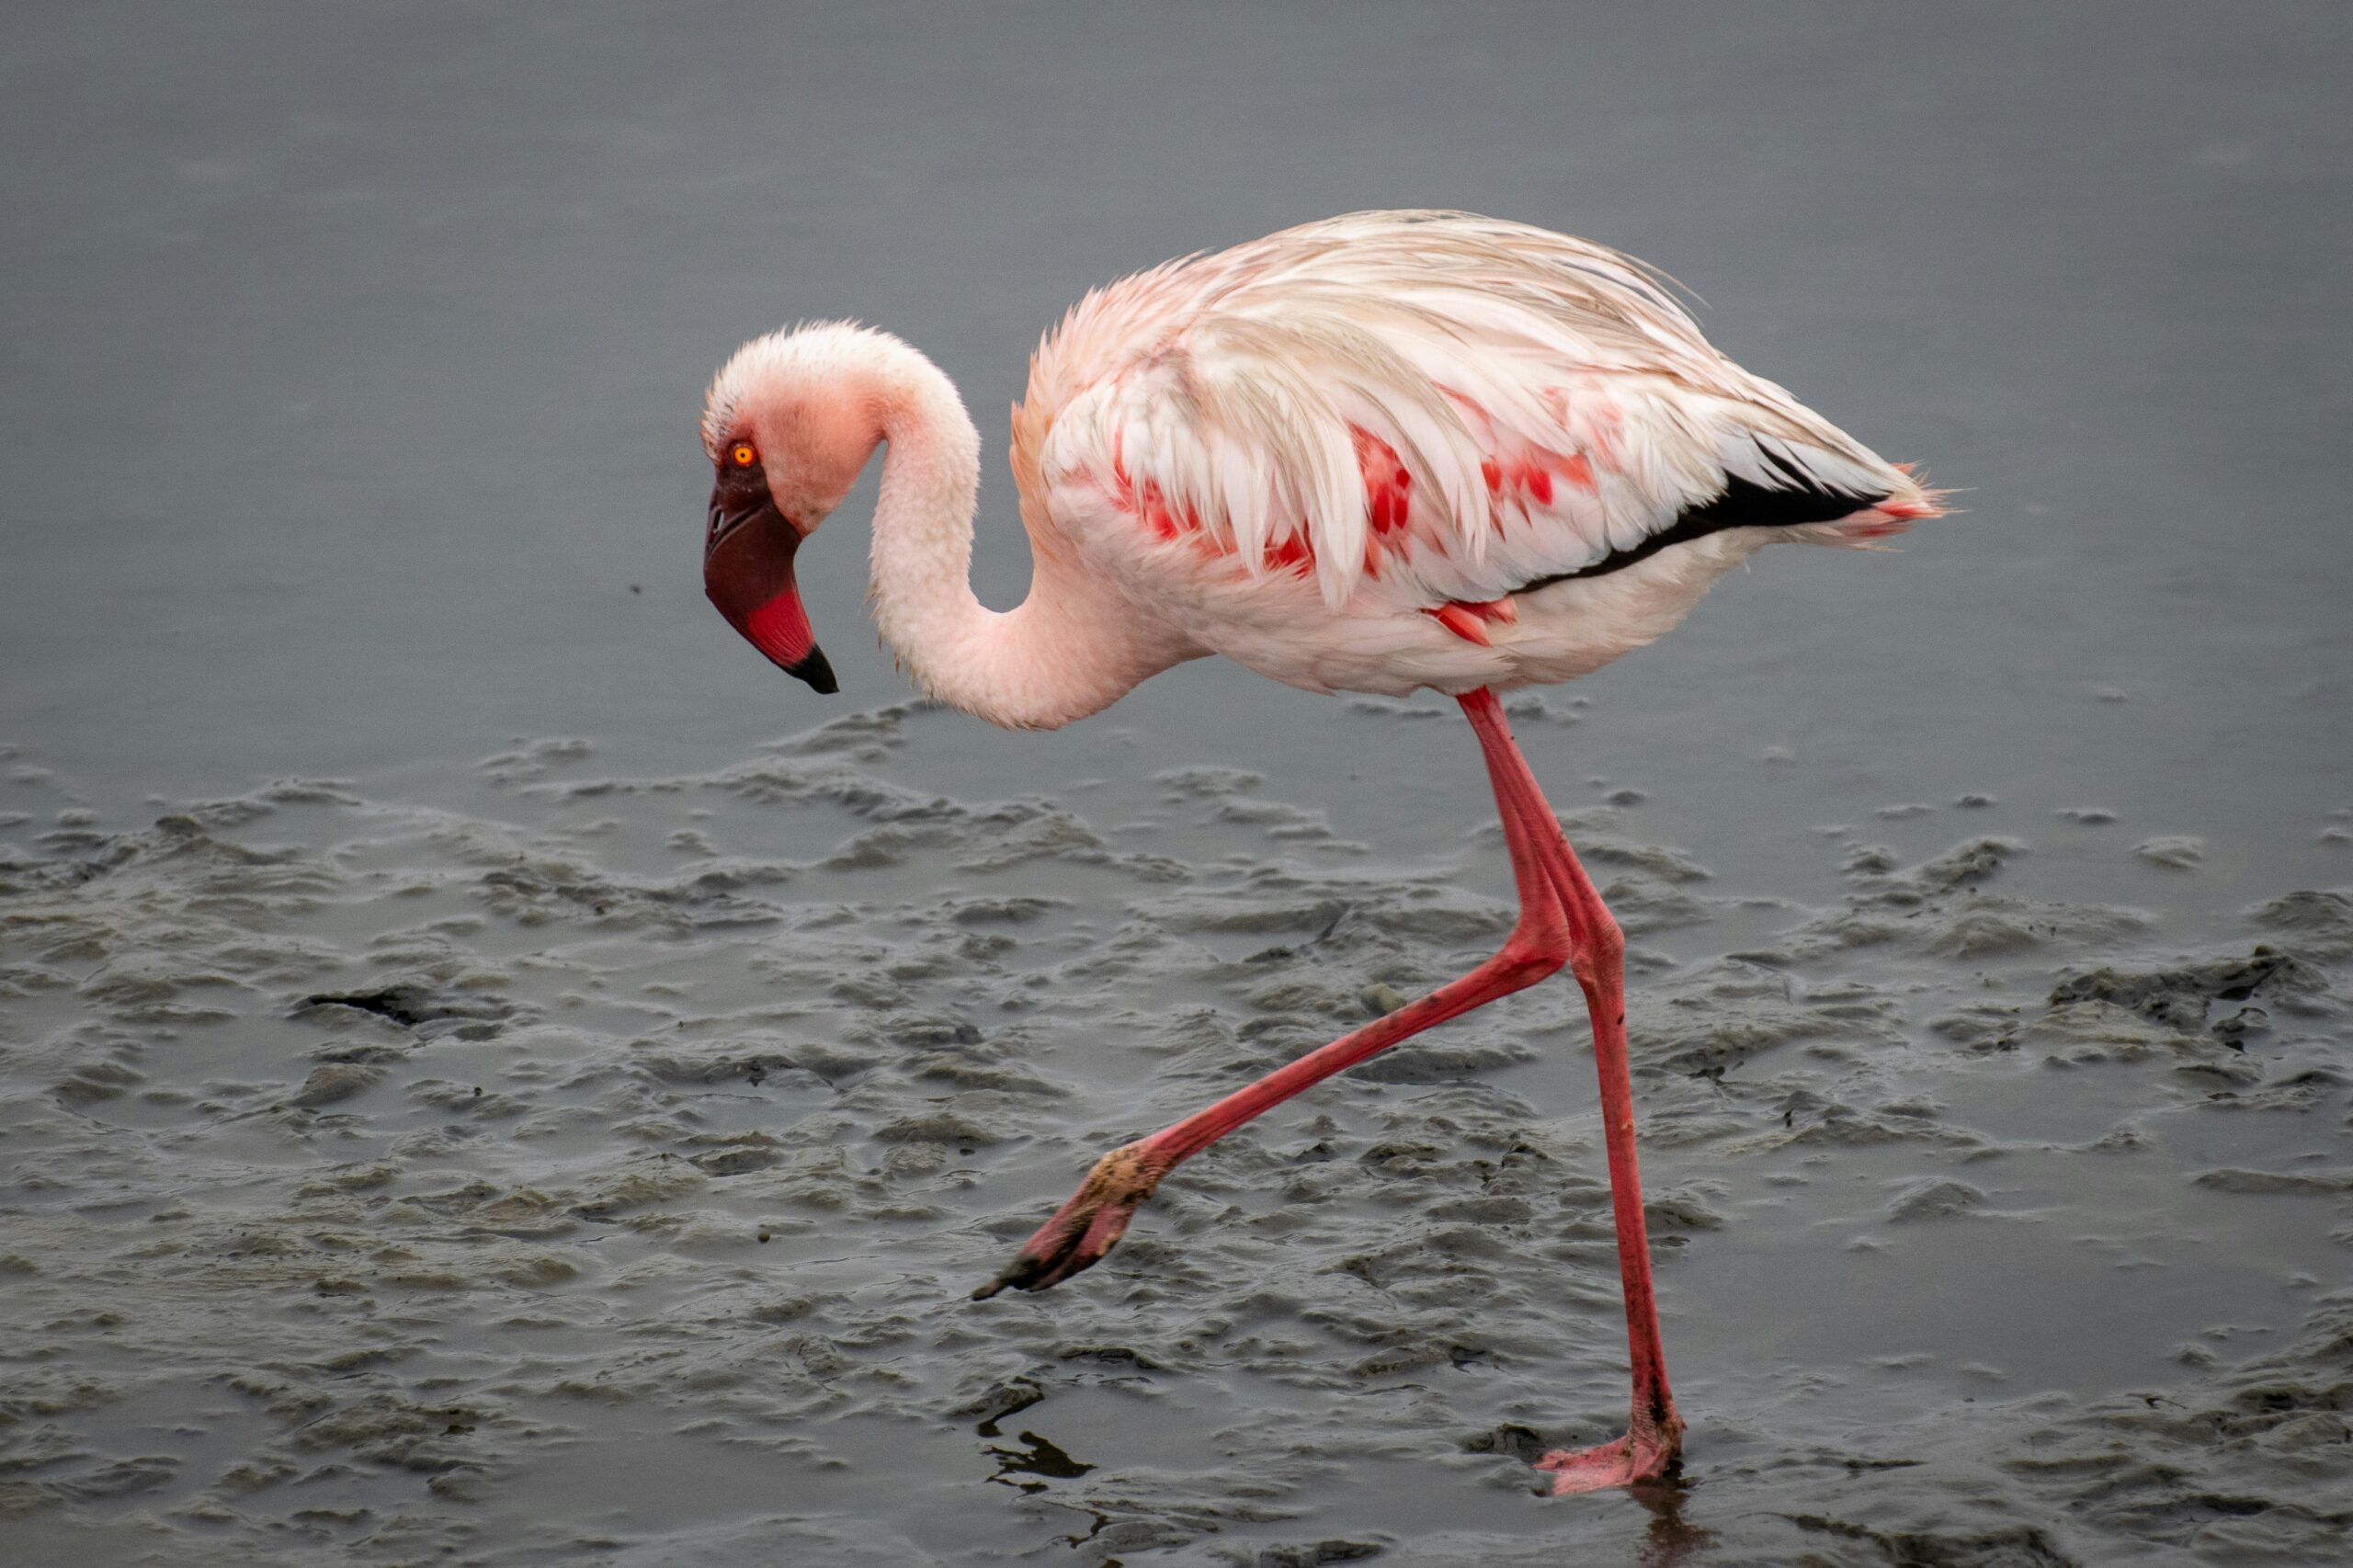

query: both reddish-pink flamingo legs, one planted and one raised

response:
[972,690,1682,1493]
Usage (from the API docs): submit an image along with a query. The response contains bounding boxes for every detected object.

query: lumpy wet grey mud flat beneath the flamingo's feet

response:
[0,699,2353,1568]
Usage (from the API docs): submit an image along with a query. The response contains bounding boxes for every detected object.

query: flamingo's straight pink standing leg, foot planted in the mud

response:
[1461,692,1682,1495]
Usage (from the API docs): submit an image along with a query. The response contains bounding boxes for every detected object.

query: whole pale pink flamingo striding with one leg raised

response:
[701,212,1941,1493]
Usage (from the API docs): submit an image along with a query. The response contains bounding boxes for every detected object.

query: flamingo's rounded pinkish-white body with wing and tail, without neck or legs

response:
[1014,212,1934,695]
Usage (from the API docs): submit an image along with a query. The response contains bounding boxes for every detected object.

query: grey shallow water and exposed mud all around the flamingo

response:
[0,7,2353,1563]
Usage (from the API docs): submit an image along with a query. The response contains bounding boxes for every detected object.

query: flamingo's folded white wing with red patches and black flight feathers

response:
[1017,212,1934,609]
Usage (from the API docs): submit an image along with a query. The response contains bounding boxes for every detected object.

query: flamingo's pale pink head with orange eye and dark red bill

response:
[701,323,882,692]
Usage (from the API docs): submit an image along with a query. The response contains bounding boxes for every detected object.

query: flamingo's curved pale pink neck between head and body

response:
[870,344,1184,730]
